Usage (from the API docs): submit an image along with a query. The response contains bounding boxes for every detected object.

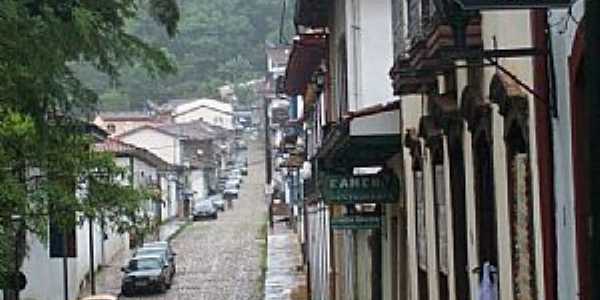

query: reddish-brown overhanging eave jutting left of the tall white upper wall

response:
[284,35,326,96]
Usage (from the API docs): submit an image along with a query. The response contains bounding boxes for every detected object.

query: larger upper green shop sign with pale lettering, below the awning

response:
[320,172,400,204]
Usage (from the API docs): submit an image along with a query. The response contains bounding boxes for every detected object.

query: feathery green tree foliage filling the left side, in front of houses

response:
[0,0,179,286]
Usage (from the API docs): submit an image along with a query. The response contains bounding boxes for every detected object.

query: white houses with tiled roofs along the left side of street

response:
[13,99,241,300]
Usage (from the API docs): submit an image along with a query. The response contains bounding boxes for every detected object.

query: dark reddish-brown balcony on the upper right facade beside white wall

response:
[390,0,483,95]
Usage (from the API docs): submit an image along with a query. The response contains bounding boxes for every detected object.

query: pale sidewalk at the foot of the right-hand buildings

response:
[265,223,307,300]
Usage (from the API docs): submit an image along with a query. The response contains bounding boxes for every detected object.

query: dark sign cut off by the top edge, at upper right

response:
[456,0,573,9]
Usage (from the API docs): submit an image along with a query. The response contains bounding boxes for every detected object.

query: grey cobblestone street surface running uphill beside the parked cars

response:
[82,144,266,300]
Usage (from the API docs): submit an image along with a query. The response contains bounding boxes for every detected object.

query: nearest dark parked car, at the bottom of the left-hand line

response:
[121,255,171,296]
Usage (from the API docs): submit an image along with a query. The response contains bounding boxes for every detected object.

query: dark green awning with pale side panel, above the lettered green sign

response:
[317,101,402,168]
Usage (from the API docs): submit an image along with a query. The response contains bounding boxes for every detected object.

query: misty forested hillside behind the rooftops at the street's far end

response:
[79,0,293,110]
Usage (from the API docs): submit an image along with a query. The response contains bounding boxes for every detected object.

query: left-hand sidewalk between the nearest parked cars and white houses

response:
[79,219,188,298]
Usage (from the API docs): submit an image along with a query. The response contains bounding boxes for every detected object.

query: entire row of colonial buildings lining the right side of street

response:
[276,0,593,300]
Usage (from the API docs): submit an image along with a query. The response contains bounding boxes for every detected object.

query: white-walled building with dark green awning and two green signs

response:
[285,0,401,299]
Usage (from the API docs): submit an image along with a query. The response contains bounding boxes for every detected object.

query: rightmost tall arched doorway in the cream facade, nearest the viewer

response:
[489,73,539,299]
